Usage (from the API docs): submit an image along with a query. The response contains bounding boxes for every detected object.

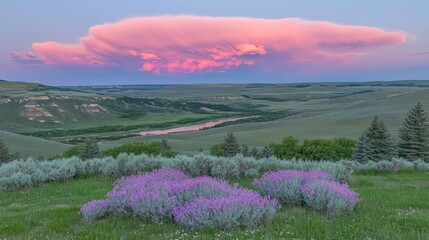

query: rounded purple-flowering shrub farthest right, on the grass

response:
[301,180,359,216]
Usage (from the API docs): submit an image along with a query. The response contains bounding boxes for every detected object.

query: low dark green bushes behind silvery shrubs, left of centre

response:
[103,140,177,158]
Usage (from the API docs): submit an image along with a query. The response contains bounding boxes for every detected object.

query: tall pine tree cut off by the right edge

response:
[398,103,429,161]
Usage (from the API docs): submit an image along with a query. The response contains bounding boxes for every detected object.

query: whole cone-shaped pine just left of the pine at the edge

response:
[353,116,395,162]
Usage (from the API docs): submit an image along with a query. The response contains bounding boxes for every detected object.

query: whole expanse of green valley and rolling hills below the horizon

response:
[0,81,429,157]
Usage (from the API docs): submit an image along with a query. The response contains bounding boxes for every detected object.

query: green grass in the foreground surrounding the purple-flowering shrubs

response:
[0,172,429,239]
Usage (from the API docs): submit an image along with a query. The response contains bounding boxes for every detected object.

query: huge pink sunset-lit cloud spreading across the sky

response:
[11,16,406,73]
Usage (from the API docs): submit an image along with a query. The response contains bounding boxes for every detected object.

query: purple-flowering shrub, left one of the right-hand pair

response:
[253,170,333,204]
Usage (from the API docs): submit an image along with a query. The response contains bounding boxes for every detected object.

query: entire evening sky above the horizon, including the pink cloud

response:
[0,0,429,86]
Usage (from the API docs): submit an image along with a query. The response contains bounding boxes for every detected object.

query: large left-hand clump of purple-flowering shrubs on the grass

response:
[81,168,277,228]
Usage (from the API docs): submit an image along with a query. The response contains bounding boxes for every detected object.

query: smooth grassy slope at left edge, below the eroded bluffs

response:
[0,130,69,157]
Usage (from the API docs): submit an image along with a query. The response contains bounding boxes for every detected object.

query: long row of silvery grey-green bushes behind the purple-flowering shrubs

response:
[0,153,429,190]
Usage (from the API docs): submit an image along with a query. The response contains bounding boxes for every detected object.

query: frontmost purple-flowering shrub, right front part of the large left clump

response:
[173,189,279,228]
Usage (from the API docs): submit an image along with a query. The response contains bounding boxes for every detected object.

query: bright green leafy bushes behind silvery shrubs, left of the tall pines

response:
[266,136,356,161]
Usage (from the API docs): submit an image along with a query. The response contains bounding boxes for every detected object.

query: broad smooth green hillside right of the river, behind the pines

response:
[106,81,429,151]
